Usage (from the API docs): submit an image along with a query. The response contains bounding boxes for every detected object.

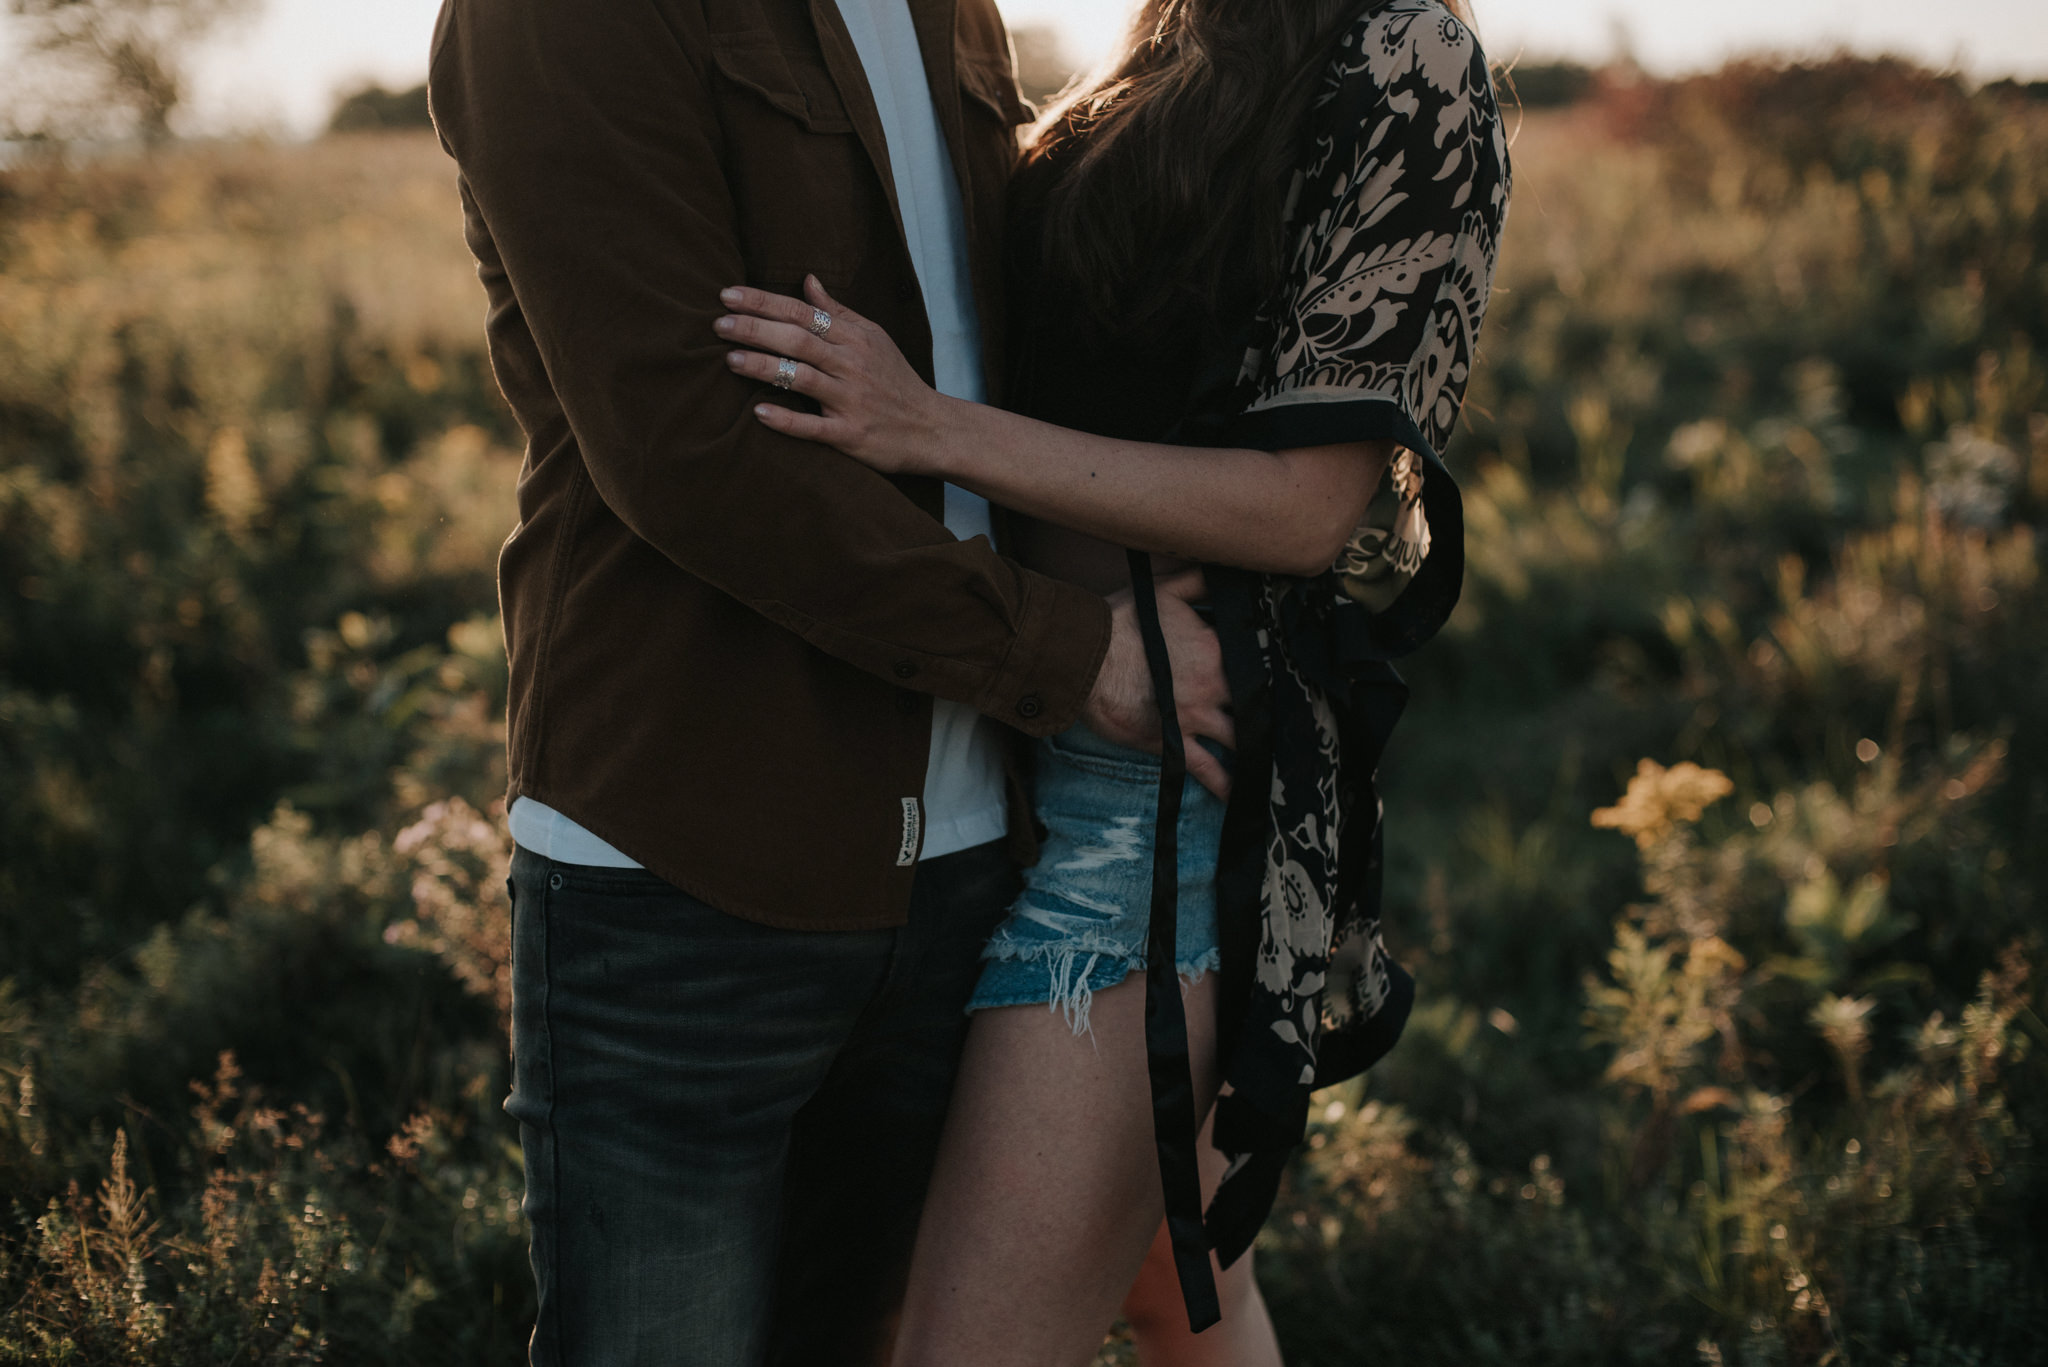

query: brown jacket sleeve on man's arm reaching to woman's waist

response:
[430,0,1108,734]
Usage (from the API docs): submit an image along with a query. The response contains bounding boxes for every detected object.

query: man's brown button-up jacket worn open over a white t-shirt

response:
[430,0,1108,928]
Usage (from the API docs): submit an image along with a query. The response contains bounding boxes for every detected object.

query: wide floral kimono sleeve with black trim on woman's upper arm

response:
[1233,0,1509,660]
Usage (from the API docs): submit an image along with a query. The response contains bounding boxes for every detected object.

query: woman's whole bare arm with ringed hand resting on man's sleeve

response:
[717,279,1393,574]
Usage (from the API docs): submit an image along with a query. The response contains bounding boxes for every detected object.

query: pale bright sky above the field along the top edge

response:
[0,0,2048,133]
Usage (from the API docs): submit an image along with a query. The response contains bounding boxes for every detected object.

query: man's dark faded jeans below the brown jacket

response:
[506,844,1016,1367]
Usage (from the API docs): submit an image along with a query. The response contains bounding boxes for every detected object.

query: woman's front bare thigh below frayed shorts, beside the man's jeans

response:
[895,974,1217,1367]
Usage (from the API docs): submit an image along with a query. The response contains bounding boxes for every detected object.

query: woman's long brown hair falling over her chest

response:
[1028,0,1468,322]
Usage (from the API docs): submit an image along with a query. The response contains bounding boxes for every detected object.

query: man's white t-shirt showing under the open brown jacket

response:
[512,0,1008,869]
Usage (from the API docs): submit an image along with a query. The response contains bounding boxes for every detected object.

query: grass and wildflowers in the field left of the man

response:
[0,139,532,1363]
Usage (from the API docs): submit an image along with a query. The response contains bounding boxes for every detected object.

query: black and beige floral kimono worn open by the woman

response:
[1141,0,1509,1320]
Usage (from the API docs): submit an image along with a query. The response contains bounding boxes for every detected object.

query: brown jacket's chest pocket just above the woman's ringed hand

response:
[711,33,872,287]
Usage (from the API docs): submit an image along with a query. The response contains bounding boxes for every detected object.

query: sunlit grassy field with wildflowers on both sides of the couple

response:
[0,61,2048,1367]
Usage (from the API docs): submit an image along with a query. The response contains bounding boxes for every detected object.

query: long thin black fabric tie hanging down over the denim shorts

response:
[1130,551,1223,1334]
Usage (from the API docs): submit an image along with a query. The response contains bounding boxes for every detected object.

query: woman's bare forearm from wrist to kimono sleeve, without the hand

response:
[915,400,1393,574]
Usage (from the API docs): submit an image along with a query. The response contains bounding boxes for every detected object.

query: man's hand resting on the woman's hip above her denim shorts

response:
[1081,570,1237,797]
